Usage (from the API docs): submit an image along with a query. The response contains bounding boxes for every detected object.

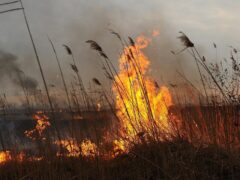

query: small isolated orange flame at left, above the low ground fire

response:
[24,111,51,139]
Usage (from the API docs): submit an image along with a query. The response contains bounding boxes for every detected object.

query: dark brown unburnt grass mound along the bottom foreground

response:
[0,139,240,179]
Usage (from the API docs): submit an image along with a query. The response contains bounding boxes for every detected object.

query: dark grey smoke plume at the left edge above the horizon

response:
[0,50,38,90]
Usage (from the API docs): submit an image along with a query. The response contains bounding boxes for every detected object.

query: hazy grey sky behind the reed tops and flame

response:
[0,0,240,99]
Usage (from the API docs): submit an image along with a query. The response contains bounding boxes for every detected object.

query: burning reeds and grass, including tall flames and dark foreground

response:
[0,31,240,179]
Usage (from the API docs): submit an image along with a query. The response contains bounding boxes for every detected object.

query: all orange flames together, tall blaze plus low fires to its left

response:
[0,31,172,164]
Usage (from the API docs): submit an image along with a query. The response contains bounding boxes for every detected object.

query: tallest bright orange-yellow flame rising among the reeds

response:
[113,33,172,142]
